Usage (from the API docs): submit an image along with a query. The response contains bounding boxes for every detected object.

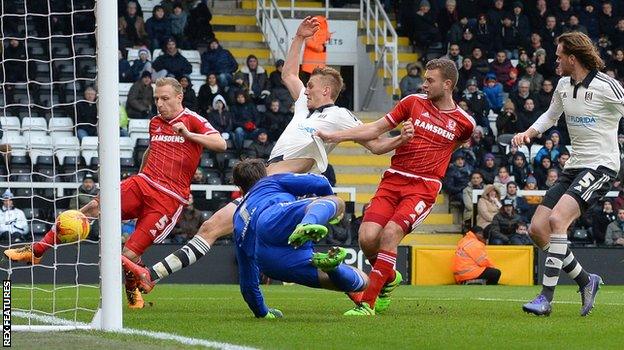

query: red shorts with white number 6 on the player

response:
[363,171,442,234]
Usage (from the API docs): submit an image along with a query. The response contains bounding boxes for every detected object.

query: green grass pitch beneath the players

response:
[13,284,624,350]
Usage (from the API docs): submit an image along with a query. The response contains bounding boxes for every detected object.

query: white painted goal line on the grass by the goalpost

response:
[11,311,256,350]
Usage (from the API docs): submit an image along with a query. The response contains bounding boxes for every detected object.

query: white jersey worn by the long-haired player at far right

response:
[531,70,624,173]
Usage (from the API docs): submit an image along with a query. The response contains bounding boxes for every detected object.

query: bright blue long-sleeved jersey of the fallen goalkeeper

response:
[234,173,334,317]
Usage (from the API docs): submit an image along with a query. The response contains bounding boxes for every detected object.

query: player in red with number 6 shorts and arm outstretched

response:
[317,59,475,315]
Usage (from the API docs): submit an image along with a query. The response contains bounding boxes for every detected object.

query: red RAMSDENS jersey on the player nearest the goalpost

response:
[139,108,218,204]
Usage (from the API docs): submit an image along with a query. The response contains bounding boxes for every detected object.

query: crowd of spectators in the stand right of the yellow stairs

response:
[398,0,624,244]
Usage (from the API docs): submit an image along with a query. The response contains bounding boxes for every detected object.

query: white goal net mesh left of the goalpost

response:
[0,0,102,325]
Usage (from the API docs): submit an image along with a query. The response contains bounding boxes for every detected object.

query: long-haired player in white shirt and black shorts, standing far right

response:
[512,32,624,316]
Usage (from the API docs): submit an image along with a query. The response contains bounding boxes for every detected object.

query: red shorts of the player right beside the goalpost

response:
[121,175,183,256]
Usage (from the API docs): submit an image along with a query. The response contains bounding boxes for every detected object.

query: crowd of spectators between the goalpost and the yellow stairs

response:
[119,0,294,158]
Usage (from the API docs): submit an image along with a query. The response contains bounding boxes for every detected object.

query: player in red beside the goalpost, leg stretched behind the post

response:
[4,78,226,308]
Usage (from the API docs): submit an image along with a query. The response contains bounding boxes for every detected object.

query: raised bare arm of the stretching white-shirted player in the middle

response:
[282,16,319,100]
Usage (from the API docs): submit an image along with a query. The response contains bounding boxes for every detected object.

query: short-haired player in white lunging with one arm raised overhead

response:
[125,17,414,304]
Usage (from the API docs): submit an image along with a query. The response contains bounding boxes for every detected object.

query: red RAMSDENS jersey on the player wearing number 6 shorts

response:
[385,94,475,180]
